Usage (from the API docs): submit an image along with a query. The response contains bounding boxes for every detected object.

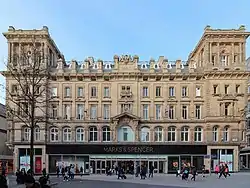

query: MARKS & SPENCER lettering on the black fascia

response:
[104,146,154,153]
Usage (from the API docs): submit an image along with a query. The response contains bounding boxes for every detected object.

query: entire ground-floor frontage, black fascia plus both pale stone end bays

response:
[14,144,239,174]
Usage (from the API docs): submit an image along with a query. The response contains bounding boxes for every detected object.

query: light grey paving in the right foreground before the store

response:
[76,173,250,188]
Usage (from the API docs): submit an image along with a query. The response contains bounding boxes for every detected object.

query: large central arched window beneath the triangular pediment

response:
[117,126,135,142]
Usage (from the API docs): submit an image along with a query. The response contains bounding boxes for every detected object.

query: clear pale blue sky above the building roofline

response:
[0,0,250,103]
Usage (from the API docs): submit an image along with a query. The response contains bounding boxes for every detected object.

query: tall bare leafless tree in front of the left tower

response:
[1,39,55,173]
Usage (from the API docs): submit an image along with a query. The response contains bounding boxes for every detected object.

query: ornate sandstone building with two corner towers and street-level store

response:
[4,26,250,173]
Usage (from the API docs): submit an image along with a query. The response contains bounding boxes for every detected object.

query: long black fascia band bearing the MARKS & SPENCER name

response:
[46,144,207,155]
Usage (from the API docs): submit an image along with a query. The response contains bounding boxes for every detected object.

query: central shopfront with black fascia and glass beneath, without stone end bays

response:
[46,144,207,174]
